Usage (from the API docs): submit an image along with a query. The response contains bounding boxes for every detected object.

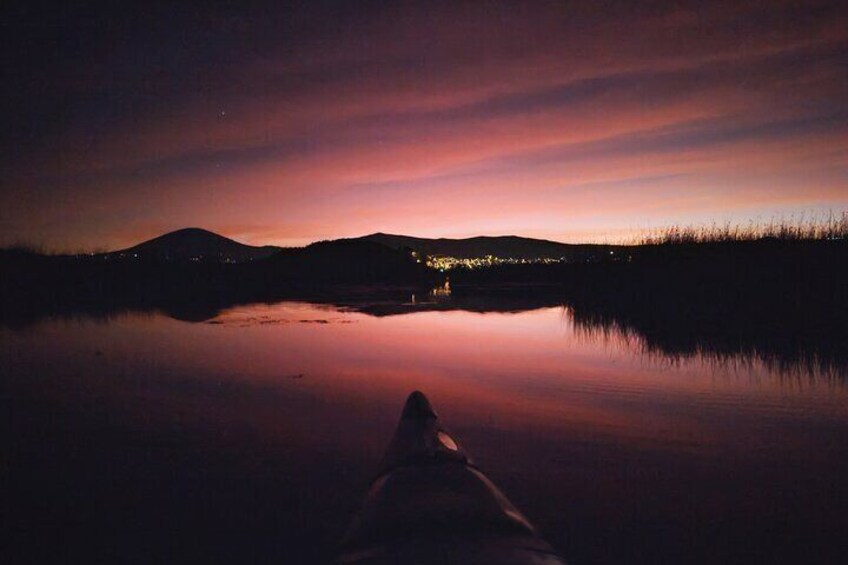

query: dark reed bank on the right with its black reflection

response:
[451,234,848,379]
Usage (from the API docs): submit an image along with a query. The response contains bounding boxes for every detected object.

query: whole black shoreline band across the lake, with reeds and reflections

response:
[0,215,848,378]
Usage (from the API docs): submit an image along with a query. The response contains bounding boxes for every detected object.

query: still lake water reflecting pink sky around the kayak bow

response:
[0,303,848,564]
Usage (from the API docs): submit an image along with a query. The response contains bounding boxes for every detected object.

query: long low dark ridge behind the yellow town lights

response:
[359,233,616,259]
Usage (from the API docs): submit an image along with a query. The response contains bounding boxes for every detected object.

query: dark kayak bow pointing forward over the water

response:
[337,391,564,565]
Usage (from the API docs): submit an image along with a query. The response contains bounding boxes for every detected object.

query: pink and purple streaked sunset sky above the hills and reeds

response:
[0,0,848,251]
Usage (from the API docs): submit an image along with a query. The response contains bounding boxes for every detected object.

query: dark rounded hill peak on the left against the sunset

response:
[105,228,282,263]
